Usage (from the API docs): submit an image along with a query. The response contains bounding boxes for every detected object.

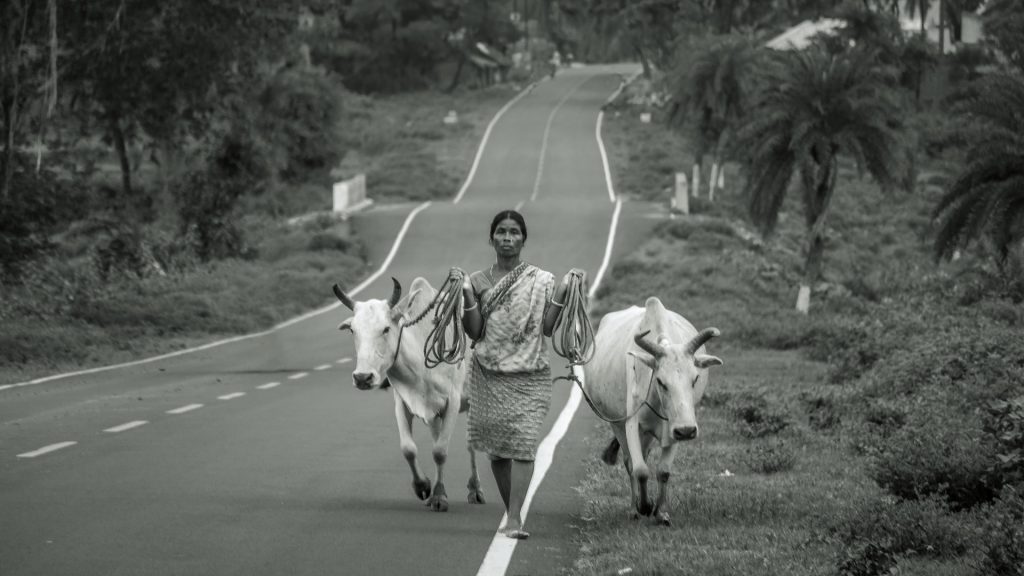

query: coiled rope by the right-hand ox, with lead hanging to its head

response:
[551,269,667,423]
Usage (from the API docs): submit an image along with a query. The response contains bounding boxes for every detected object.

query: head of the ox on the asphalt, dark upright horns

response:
[334,278,419,389]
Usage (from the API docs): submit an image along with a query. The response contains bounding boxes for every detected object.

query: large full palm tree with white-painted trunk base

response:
[736,45,907,314]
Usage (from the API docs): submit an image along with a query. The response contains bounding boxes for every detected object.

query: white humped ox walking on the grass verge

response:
[585,297,722,525]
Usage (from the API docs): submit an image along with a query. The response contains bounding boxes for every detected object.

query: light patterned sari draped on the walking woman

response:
[466,262,555,460]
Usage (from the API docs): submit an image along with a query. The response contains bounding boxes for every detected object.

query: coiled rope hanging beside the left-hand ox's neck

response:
[419,268,466,368]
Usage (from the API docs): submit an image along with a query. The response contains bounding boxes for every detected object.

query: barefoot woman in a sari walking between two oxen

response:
[463,210,568,539]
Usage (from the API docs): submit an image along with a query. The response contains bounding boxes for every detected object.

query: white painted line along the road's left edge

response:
[8,82,537,392]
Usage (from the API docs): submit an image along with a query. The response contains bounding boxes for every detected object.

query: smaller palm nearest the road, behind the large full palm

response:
[669,36,756,200]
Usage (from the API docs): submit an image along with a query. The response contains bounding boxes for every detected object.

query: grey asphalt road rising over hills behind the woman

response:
[0,63,652,576]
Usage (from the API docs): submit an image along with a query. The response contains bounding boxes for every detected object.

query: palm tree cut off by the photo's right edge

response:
[932,74,1024,265]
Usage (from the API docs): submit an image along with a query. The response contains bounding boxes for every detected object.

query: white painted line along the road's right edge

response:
[476,76,625,576]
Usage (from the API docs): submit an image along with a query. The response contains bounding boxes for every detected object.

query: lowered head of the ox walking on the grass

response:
[630,328,722,441]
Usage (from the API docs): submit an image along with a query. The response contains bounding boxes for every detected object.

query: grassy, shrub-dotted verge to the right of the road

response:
[569,97,1024,576]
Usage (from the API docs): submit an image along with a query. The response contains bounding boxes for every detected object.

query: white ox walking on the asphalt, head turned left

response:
[334,278,483,511]
